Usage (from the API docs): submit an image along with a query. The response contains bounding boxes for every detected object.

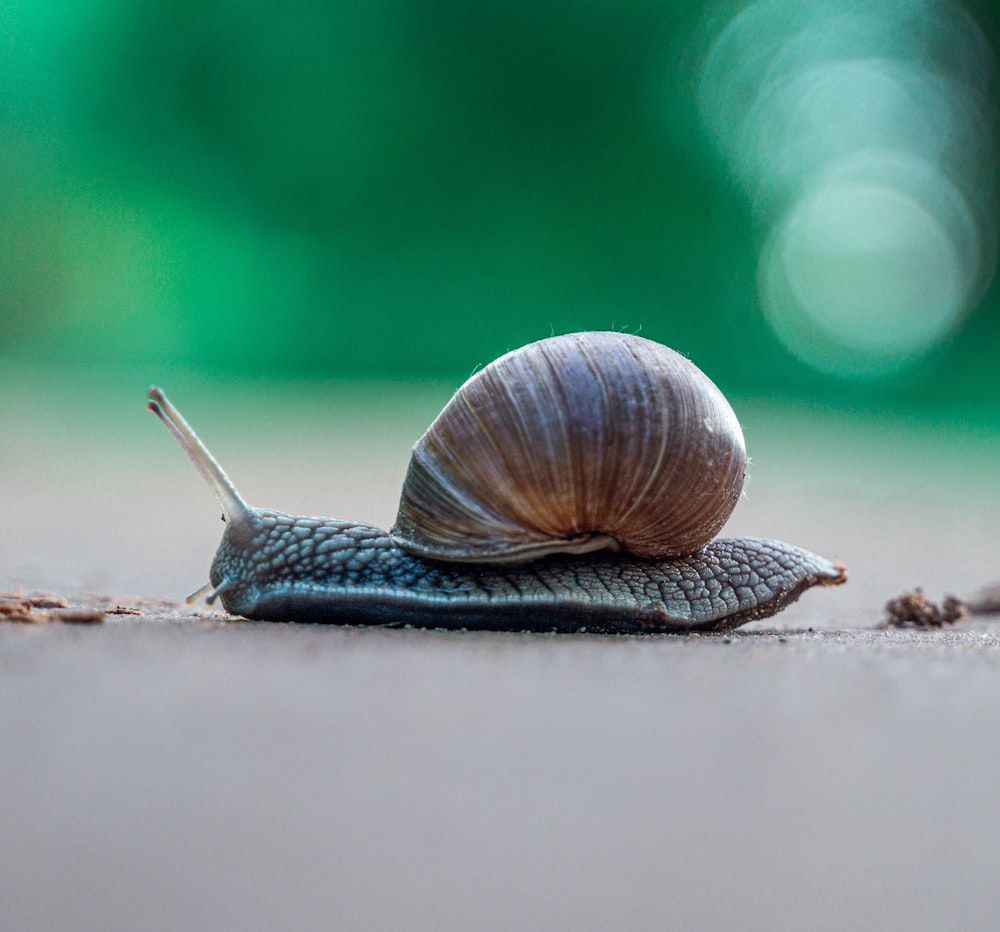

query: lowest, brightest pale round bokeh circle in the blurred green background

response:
[759,181,965,377]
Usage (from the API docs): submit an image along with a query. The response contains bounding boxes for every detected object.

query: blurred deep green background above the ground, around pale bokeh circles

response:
[0,0,1000,409]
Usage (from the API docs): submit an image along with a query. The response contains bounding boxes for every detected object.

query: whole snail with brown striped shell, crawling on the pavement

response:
[147,332,846,633]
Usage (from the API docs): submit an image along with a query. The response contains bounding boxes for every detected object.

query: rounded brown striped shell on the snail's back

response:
[390,332,746,563]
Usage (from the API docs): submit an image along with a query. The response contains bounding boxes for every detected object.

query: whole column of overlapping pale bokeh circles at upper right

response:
[699,0,997,378]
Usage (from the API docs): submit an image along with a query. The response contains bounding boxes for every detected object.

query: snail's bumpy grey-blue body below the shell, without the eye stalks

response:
[211,509,846,634]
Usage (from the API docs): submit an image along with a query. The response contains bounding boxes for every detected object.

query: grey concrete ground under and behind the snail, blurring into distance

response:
[0,367,1000,930]
